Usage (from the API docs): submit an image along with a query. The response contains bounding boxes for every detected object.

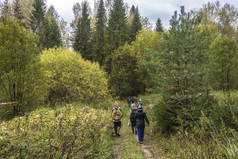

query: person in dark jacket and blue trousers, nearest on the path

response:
[135,106,150,144]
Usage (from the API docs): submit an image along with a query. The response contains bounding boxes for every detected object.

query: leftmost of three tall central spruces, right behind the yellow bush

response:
[73,1,92,60]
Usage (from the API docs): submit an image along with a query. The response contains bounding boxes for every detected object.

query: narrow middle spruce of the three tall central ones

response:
[93,0,107,65]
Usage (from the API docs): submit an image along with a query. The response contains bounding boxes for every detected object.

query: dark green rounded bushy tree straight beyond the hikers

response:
[110,44,139,97]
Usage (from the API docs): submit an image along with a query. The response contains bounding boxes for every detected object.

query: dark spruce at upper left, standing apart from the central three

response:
[30,0,47,48]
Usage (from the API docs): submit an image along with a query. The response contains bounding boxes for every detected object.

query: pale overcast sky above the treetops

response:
[43,0,238,28]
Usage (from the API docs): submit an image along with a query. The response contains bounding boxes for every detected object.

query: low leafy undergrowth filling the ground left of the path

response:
[0,105,113,158]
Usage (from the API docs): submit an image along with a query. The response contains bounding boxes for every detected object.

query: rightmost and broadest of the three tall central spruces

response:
[105,0,129,74]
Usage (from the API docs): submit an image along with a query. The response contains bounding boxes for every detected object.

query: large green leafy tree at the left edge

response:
[0,19,46,115]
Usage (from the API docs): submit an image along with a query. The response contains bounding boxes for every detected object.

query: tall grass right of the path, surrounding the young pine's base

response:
[139,92,238,159]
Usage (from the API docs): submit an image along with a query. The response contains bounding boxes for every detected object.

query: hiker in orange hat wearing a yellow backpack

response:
[111,102,123,136]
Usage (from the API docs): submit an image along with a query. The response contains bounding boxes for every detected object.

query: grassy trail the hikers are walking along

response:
[114,105,154,159]
